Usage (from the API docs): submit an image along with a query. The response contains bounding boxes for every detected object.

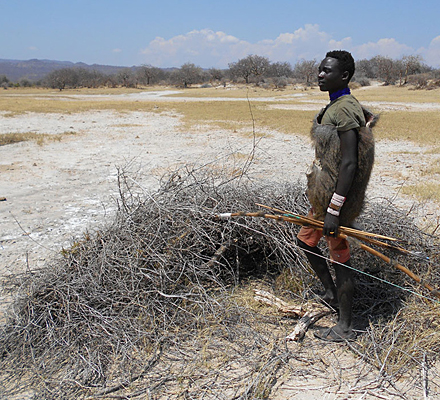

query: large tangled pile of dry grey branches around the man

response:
[0,167,440,399]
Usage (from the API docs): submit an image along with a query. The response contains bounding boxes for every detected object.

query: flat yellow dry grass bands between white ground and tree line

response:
[0,86,440,146]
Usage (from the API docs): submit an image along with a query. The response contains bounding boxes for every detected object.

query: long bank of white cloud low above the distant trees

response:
[141,24,440,68]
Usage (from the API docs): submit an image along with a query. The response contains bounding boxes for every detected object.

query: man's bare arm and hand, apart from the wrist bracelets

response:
[322,129,358,236]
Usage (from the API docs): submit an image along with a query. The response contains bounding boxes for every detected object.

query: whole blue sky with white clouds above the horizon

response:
[0,0,440,68]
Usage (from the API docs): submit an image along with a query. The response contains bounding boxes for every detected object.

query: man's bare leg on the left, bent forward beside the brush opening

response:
[297,239,338,306]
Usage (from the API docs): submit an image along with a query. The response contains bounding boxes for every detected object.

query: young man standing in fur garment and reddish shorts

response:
[298,50,375,342]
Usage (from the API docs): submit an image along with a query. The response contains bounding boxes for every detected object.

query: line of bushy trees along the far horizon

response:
[0,55,440,90]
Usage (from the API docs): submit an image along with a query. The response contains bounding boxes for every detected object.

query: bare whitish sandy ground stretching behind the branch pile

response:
[0,89,440,399]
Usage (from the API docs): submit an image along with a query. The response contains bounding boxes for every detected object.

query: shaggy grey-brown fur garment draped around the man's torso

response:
[307,107,378,226]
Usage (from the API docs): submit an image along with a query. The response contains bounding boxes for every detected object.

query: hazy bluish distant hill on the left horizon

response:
[0,59,131,82]
